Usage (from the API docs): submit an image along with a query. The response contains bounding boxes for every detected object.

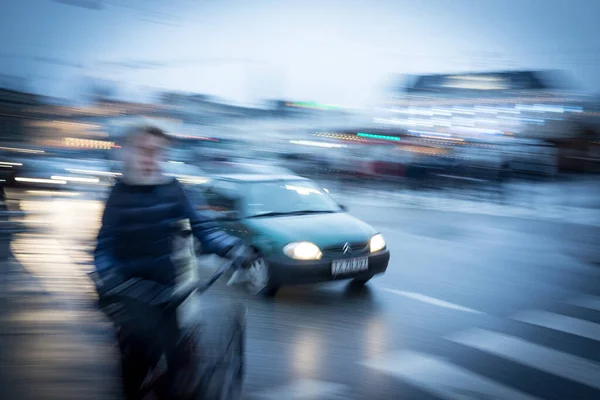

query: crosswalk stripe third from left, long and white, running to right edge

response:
[446,328,600,389]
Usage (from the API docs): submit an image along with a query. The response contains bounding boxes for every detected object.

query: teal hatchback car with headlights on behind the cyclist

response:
[201,174,390,296]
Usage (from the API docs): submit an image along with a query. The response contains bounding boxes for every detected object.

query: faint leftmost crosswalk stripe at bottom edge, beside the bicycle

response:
[250,379,349,400]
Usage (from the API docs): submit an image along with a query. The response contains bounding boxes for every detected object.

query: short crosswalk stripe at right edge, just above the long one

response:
[511,310,600,340]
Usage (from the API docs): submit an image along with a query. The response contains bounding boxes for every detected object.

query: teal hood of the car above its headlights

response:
[246,212,377,248]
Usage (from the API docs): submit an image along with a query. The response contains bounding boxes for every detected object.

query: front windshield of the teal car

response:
[246,181,341,217]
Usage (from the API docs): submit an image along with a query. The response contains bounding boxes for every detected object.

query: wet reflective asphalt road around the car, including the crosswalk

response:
[2,193,600,400]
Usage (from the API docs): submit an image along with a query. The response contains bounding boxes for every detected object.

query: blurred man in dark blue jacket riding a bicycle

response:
[95,127,251,398]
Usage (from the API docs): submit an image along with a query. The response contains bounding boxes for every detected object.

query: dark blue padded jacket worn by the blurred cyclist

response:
[94,179,240,286]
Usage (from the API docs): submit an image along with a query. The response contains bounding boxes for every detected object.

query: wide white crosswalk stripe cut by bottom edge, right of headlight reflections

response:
[361,350,537,400]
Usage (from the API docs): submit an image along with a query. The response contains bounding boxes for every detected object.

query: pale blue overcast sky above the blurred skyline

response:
[0,0,600,106]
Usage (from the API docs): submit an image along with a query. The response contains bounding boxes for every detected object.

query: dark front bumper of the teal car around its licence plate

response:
[267,249,390,286]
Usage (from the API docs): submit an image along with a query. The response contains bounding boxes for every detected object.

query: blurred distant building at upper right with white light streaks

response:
[380,71,588,139]
